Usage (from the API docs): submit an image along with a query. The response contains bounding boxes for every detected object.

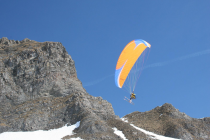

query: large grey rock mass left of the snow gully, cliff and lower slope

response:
[0,38,154,140]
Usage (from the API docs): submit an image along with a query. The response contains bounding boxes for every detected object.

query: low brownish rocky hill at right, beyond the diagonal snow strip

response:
[124,103,210,140]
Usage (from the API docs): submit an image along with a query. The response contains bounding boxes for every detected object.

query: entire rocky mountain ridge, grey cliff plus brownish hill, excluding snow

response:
[0,37,210,140]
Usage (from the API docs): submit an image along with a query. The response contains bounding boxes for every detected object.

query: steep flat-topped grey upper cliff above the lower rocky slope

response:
[0,38,82,105]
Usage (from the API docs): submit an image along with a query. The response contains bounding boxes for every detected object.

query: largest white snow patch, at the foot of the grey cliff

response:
[0,122,82,140]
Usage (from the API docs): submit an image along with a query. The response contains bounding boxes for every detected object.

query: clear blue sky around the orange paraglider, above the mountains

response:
[0,0,210,118]
